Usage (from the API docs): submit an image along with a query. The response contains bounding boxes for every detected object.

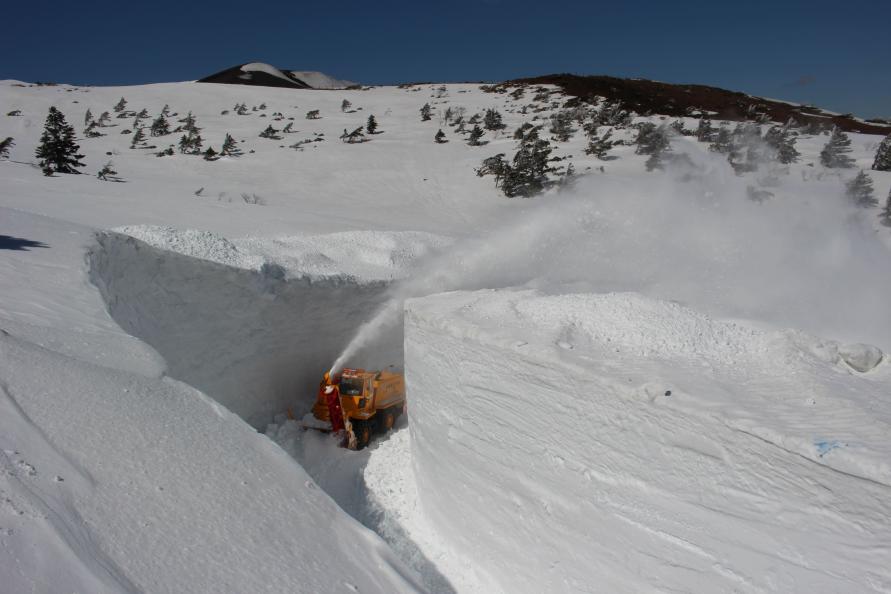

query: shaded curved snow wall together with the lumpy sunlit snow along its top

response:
[91,227,445,428]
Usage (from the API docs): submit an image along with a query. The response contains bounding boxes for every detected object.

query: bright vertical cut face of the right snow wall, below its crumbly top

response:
[405,292,891,593]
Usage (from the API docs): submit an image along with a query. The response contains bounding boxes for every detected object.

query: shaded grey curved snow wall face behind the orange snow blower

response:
[90,232,402,428]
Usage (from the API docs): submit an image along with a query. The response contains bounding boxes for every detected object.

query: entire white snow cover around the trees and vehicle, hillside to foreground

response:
[0,76,891,594]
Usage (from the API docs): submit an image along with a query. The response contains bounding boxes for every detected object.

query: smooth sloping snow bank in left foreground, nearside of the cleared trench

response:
[0,208,426,594]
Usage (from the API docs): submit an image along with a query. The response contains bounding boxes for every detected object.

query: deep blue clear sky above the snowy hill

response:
[0,0,891,117]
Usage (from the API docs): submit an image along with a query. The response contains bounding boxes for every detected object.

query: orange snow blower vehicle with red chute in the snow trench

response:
[304,369,405,450]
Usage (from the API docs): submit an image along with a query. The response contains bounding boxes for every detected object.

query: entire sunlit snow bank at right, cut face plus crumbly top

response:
[405,290,891,592]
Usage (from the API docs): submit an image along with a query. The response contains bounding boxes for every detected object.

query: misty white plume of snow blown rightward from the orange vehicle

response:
[332,139,891,371]
